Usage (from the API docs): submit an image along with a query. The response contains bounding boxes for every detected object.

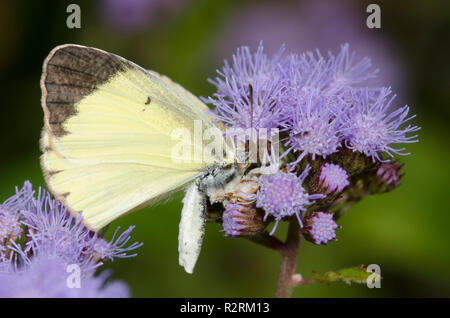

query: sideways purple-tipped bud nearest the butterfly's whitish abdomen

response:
[222,202,266,237]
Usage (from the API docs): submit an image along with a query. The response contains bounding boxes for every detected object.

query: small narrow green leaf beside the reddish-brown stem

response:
[305,265,372,285]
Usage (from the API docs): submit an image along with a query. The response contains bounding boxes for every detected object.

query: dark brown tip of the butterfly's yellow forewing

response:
[41,44,129,137]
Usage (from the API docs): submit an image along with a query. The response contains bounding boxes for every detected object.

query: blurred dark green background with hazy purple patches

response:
[0,0,450,297]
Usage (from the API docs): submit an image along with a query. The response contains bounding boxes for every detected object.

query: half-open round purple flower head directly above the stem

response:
[256,168,325,234]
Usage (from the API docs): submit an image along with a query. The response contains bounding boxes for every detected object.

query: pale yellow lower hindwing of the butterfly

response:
[41,132,198,230]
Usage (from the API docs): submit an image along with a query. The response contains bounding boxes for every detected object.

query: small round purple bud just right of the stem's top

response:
[303,212,338,245]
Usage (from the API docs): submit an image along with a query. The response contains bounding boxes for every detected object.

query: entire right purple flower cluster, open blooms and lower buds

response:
[204,44,420,244]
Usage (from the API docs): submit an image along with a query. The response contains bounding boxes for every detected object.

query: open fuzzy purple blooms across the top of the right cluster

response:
[205,44,419,164]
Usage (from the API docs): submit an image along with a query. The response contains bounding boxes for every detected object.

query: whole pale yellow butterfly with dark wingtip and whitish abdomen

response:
[41,44,238,273]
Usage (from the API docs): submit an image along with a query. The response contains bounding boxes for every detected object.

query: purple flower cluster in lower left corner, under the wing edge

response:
[0,181,142,297]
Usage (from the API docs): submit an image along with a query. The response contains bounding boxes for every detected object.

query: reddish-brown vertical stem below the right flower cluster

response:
[275,220,301,298]
